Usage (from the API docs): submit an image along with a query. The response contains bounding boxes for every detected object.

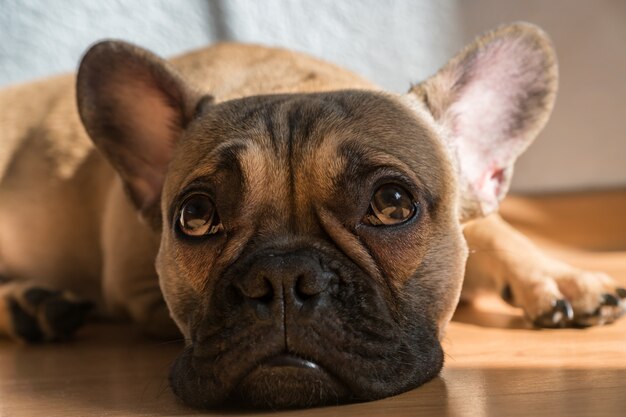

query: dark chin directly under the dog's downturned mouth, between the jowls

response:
[233,355,349,409]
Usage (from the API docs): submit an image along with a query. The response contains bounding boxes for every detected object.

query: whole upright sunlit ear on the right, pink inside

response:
[409,23,558,222]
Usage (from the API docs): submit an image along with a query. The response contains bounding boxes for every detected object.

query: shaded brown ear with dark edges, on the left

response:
[76,41,198,221]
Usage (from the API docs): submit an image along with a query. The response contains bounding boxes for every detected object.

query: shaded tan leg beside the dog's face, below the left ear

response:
[102,181,180,338]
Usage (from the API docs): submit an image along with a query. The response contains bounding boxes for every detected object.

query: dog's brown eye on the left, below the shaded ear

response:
[178,194,223,236]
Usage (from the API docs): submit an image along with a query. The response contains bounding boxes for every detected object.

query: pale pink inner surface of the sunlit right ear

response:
[446,37,545,207]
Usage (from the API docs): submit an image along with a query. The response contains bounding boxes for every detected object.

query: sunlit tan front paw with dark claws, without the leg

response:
[503,268,626,328]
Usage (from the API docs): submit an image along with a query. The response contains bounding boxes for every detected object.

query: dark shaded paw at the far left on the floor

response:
[5,287,93,343]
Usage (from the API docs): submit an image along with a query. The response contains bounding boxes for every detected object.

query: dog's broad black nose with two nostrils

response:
[234,252,334,306]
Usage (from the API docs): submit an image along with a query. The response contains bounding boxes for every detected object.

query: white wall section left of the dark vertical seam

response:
[0,0,212,86]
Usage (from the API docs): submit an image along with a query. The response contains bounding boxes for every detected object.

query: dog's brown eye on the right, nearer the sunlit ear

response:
[364,184,419,226]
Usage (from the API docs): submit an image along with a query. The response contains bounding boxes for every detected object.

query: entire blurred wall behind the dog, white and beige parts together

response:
[0,0,626,192]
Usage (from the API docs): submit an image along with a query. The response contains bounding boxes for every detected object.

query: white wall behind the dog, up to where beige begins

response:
[0,0,461,92]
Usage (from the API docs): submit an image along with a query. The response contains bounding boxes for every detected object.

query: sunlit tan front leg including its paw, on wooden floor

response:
[463,214,626,327]
